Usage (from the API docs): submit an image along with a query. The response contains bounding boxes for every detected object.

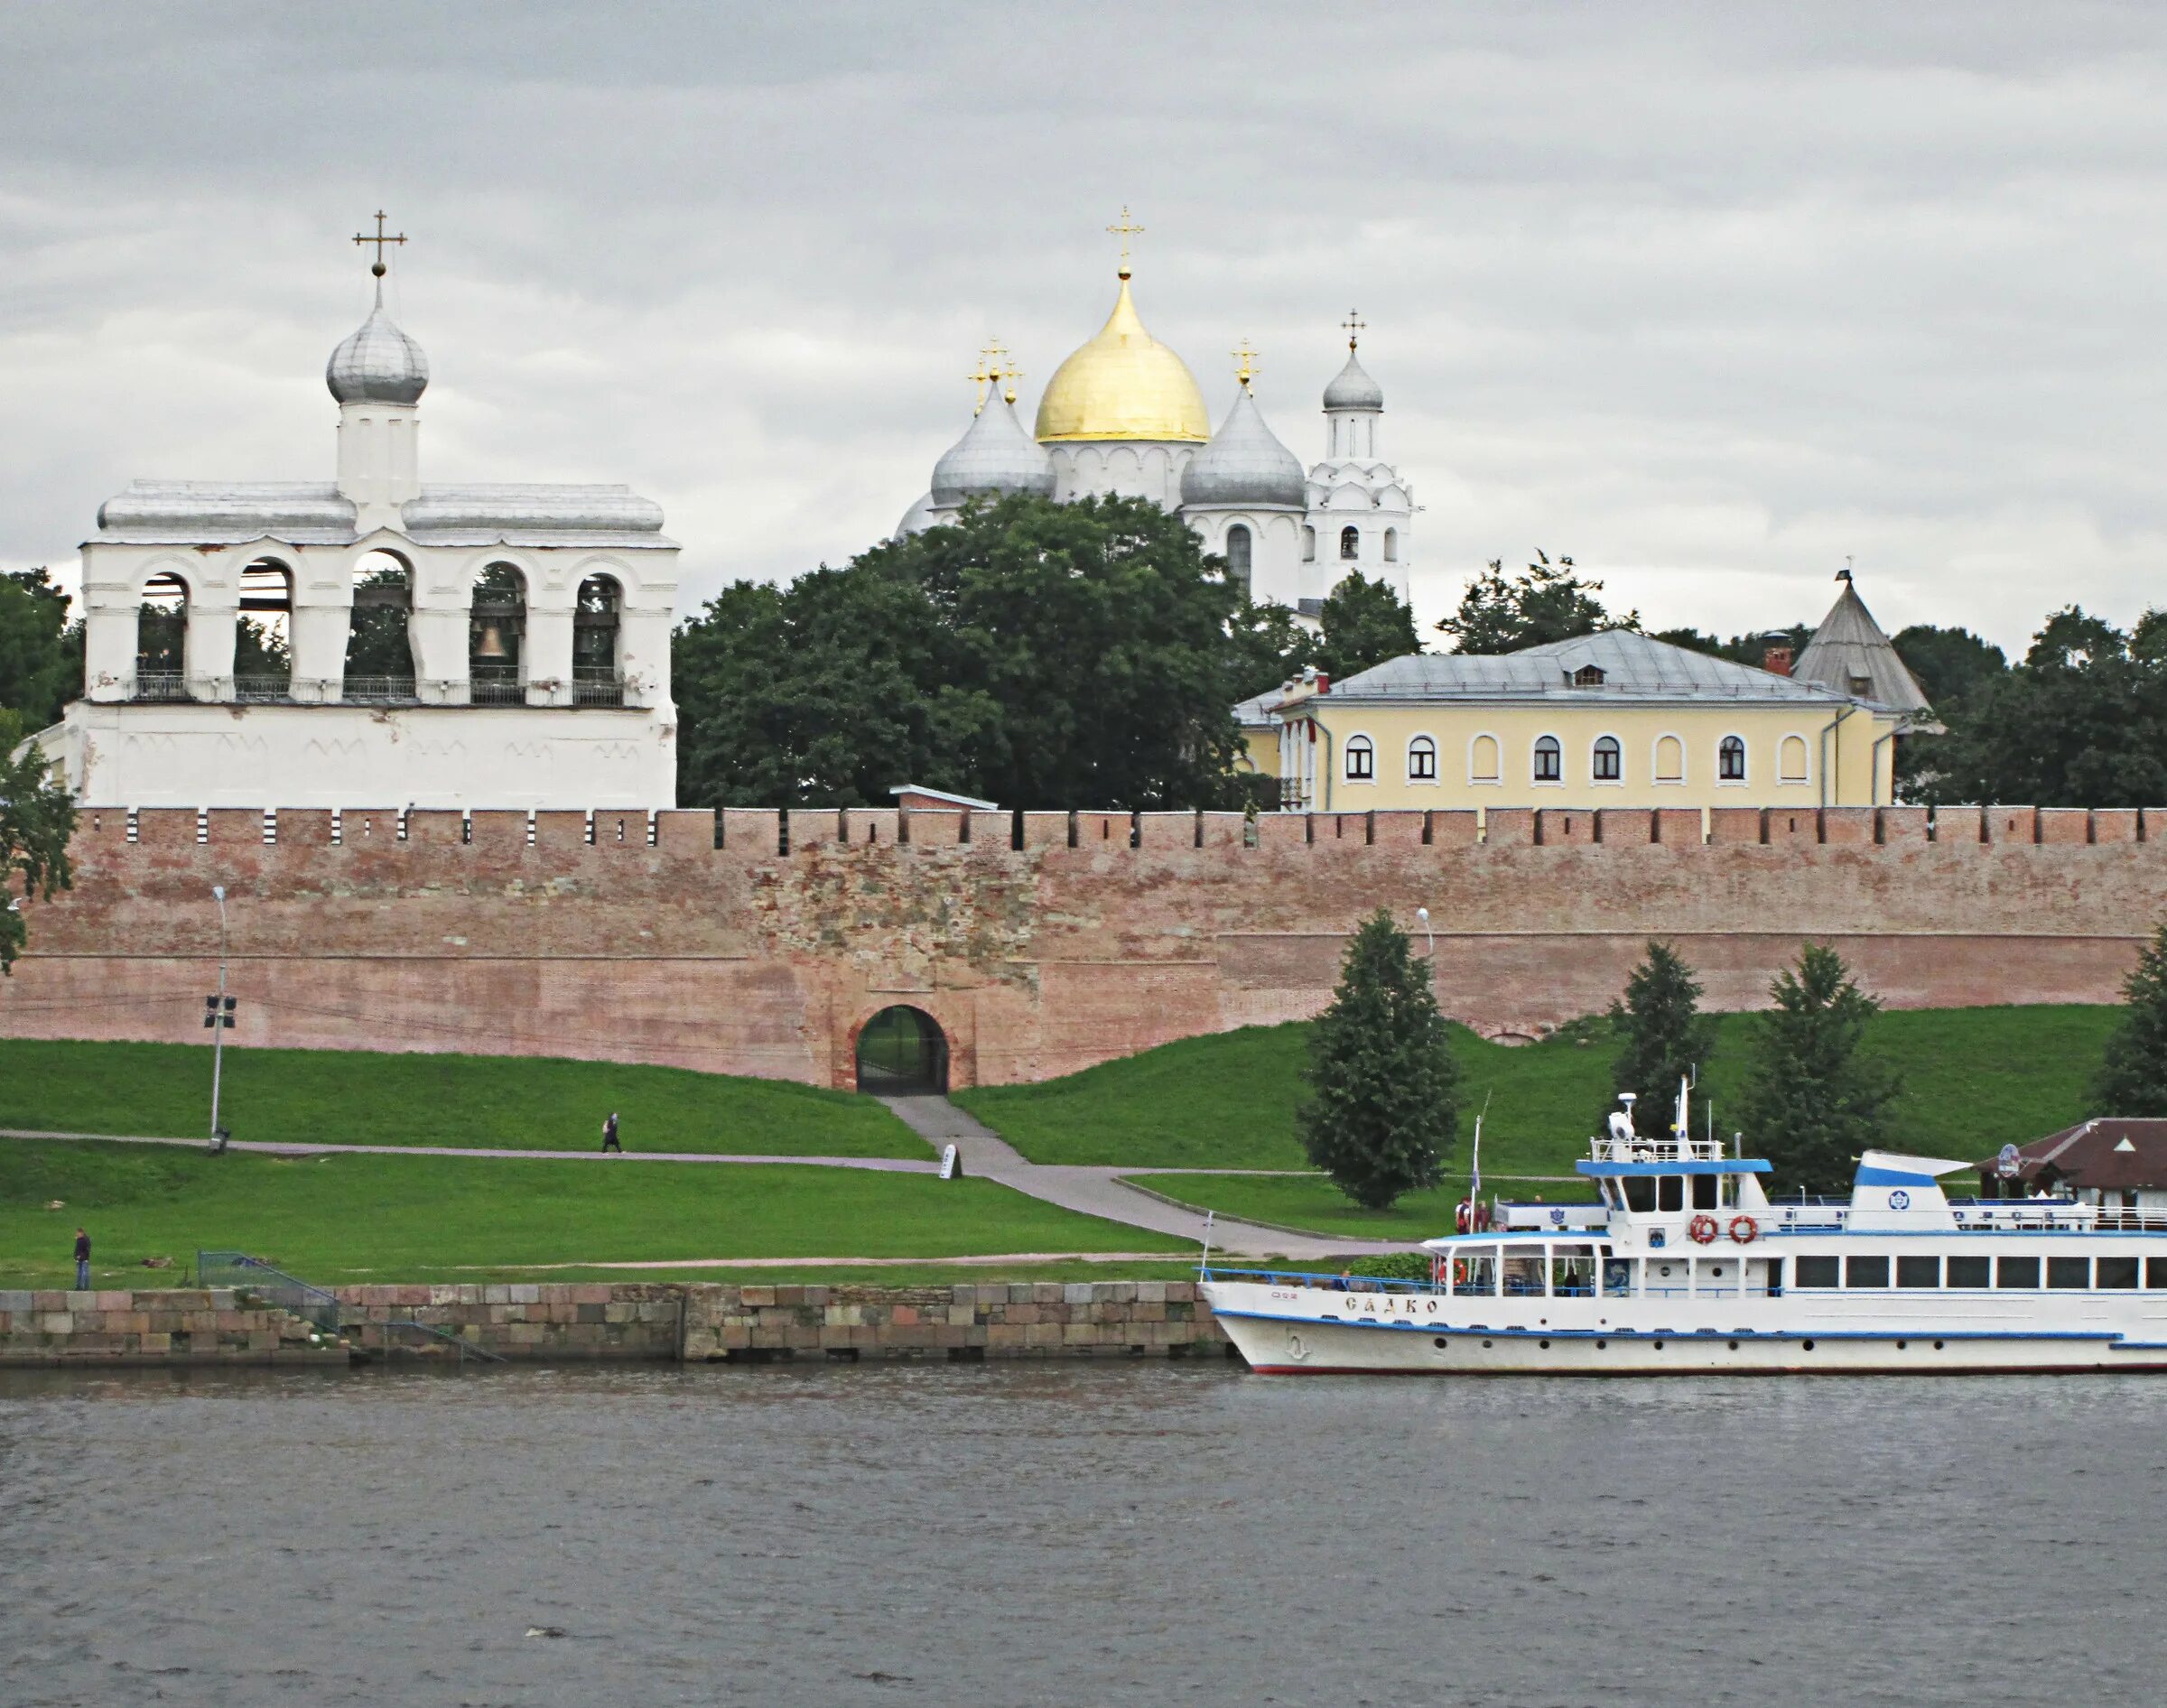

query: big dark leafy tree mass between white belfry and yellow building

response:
[672,497,1277,809]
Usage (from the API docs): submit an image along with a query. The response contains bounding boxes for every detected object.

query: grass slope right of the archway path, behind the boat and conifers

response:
[955,1006,2122,1170]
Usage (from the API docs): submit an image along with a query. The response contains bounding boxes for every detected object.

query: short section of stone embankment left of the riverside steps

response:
[0,1287,347,1366]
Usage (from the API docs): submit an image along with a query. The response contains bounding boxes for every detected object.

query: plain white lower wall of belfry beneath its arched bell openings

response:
[48,701,676,811]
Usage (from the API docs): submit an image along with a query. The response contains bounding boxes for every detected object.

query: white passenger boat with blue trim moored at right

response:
[1204,1091,2167,1377]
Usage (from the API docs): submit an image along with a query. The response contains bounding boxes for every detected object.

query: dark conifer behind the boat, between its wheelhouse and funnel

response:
[1744,942,1902,1193]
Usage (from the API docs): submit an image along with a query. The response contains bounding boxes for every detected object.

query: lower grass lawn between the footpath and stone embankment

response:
[0,1140,1179,1287]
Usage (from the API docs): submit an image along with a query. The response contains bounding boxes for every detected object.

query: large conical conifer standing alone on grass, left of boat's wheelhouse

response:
[1300,908,1461,1210]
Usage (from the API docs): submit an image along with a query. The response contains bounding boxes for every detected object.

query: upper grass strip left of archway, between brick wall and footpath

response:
[0,1038,927,1157]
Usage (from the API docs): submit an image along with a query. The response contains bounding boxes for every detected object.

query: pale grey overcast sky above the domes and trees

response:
[0,0,2167,648]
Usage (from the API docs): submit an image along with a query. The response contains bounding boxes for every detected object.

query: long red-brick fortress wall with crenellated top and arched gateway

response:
[0,806,2167,1086]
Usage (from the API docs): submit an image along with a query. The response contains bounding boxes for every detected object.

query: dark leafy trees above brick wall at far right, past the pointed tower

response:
[1913,605,2167,806]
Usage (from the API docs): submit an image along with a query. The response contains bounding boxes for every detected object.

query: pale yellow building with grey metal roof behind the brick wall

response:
[1235,628,1913,812]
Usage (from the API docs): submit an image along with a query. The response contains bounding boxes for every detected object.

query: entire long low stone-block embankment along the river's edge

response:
[0,1281,1226,1366]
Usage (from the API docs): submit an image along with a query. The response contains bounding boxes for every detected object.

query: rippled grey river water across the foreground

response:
[0,1363,2167,1708]
